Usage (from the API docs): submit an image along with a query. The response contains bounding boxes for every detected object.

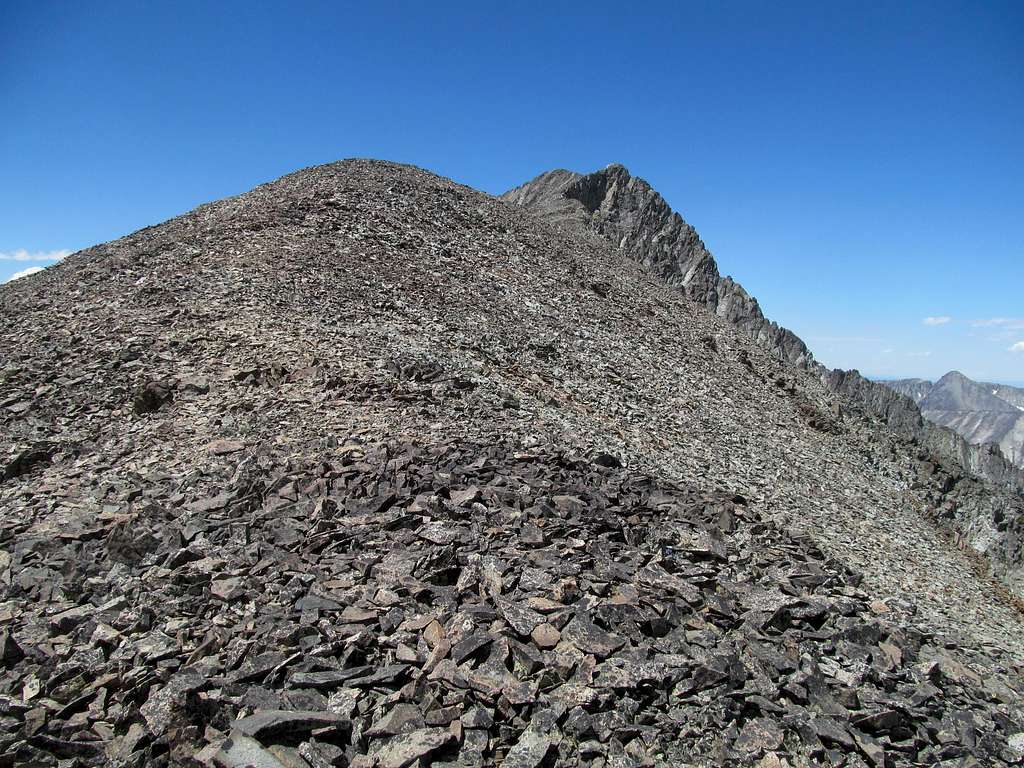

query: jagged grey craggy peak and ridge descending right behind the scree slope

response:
[503,165,1024,590]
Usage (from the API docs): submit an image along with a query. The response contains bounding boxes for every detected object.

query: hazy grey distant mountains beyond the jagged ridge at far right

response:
[883,371,1024,467]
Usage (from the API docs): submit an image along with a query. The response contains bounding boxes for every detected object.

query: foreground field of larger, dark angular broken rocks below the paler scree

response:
[0,442,1024,768]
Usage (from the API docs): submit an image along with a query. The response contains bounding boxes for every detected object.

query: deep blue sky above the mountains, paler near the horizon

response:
[0,0,1024,381]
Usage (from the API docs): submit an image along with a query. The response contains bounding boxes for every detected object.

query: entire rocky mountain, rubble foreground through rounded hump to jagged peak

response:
[0,161,1024,768]
